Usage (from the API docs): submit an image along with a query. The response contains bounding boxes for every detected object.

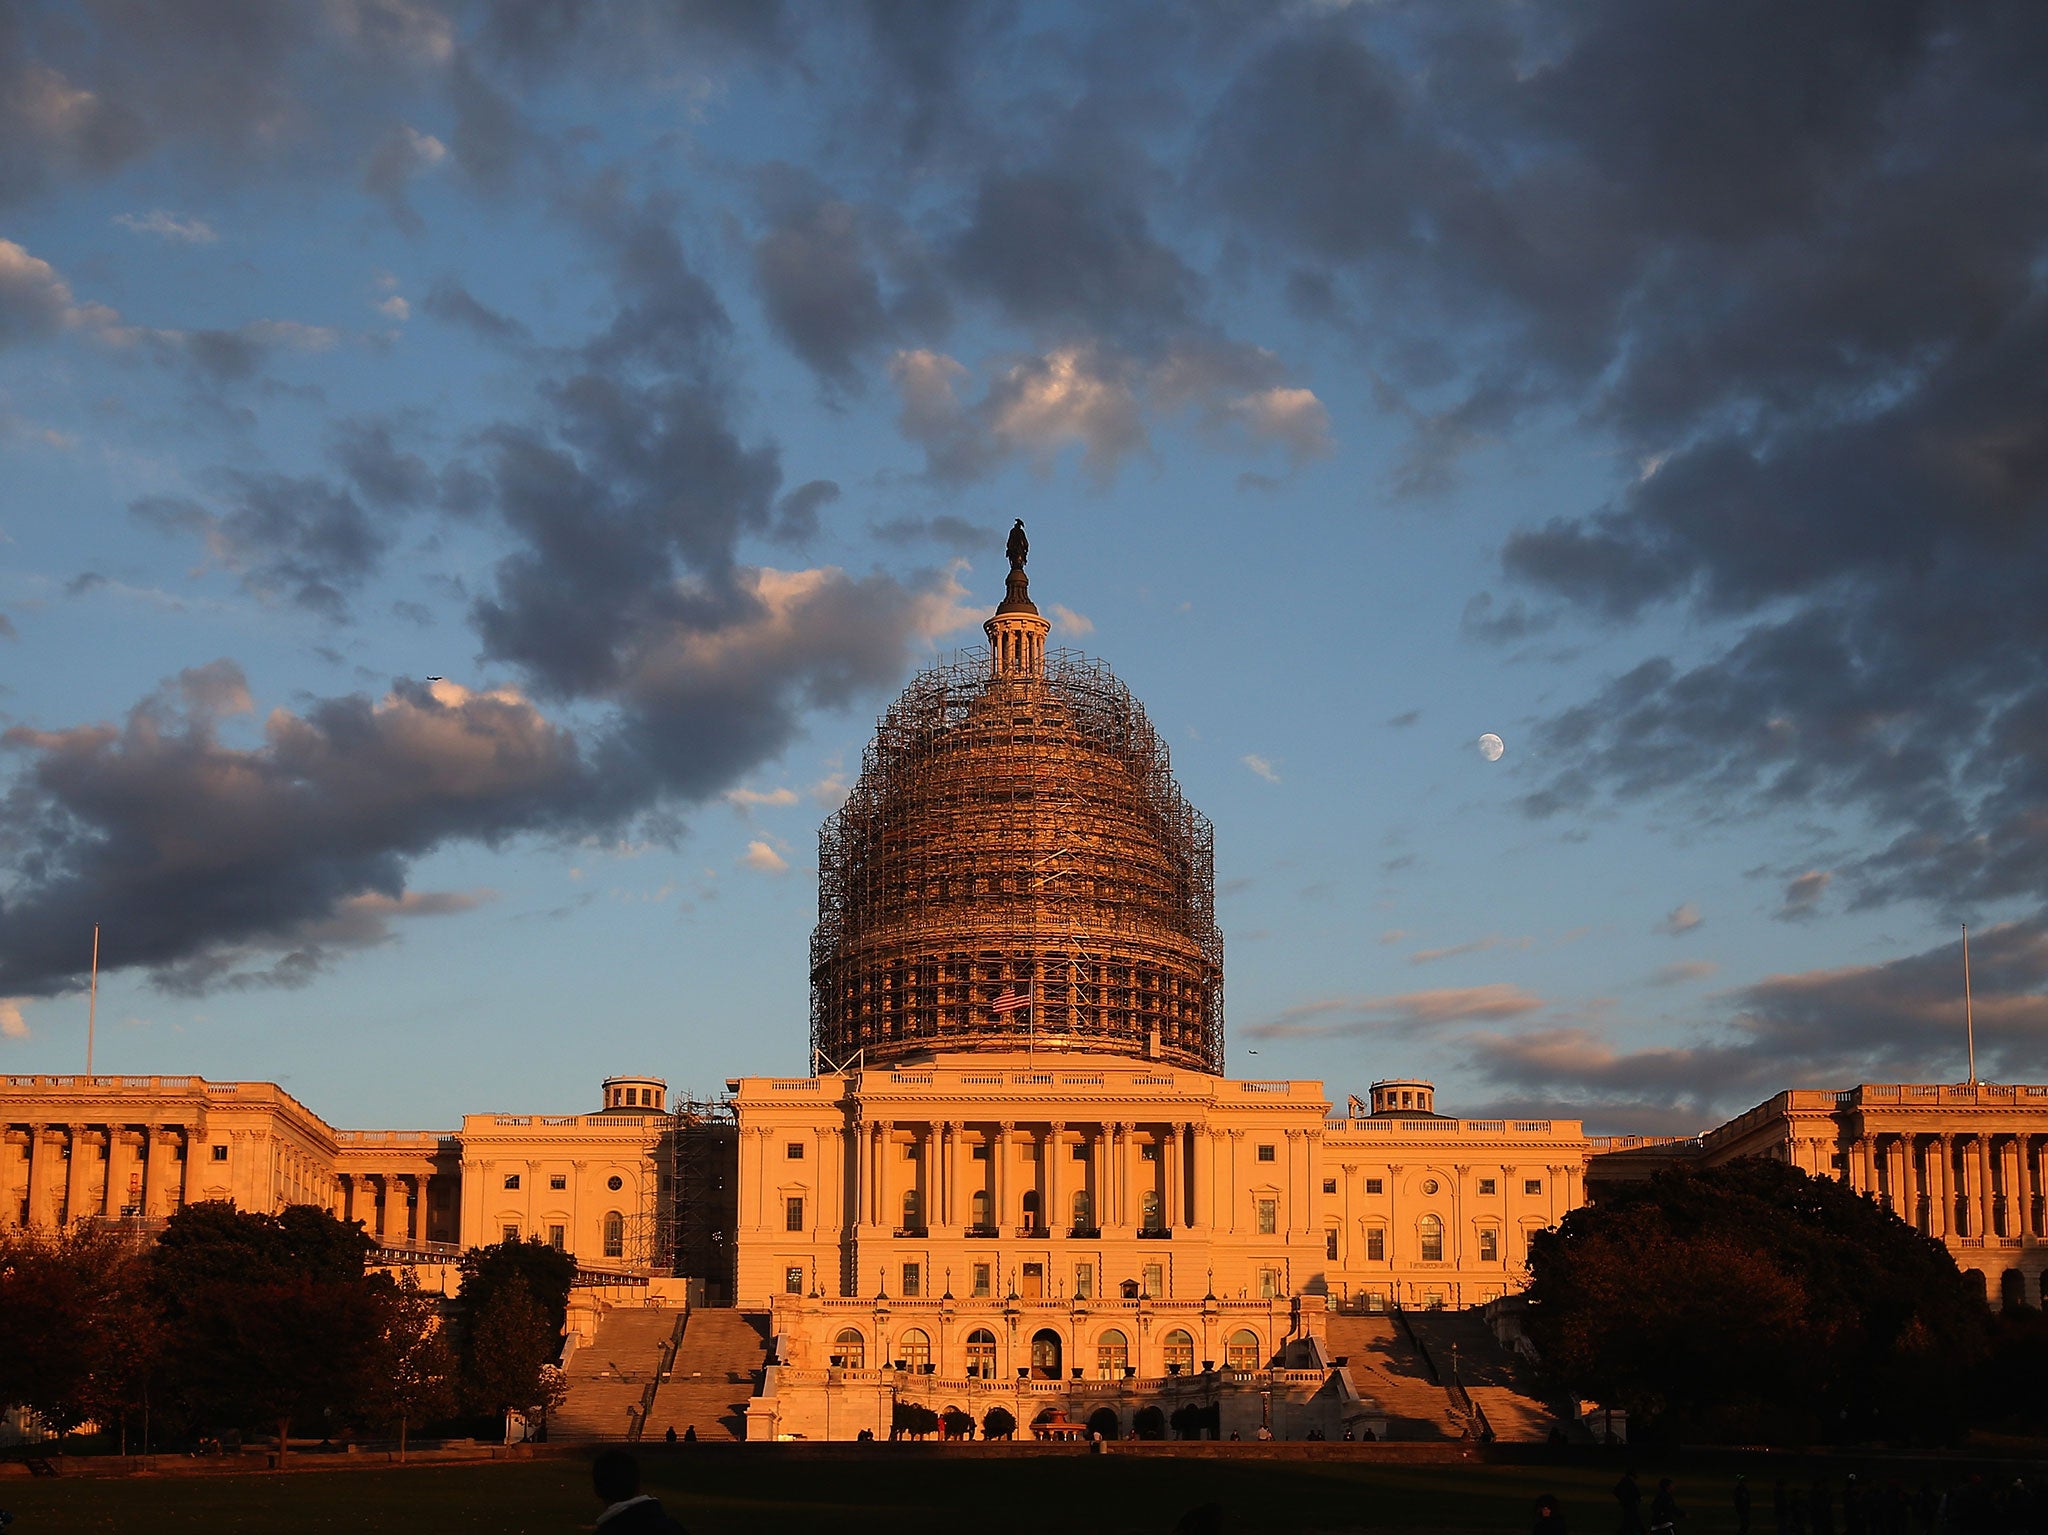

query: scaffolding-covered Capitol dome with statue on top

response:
[811,524,1223,1072]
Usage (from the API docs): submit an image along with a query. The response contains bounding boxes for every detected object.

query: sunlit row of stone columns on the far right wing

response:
[1808,1130,2044,1238]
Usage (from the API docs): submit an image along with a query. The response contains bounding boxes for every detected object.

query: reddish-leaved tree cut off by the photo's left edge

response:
[0,1222,160,1433]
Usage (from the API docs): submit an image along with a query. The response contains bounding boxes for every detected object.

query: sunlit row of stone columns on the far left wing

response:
[0,1124,199,1226]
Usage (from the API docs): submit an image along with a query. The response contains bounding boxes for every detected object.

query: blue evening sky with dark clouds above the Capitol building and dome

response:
[0,0,2048,1130]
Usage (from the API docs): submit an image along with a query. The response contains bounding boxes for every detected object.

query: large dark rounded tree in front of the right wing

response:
[1528,1160,1987,1443]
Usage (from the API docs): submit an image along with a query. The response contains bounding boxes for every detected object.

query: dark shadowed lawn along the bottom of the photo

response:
[0,1445,2042,1535]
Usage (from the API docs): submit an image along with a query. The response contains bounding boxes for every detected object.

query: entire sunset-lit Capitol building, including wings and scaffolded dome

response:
[0,530,2048,1439]
